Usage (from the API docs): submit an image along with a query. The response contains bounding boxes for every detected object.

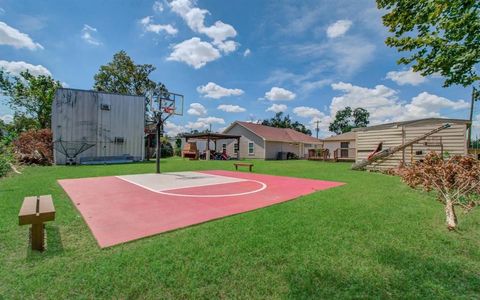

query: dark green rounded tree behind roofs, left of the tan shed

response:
[328,106,370,134]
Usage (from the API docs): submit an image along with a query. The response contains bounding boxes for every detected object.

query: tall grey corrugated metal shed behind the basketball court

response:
[52,88,145,164]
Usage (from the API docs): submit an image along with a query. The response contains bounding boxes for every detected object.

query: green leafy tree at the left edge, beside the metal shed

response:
[0,70,62,128]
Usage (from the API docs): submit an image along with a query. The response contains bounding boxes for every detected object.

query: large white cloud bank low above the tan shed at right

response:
[330,82,469,124]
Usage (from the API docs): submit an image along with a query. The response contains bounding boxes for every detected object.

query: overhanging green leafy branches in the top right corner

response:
[377,0,480,87]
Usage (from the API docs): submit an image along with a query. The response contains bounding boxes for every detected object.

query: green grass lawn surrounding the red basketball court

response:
[0,159,480,299]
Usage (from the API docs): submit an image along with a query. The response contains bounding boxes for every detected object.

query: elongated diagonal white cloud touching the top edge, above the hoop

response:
[169,0,238,53]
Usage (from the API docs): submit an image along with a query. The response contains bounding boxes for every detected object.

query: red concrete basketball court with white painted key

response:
[59,171,343,248]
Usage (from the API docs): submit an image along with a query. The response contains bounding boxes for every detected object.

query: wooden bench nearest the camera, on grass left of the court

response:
[18,195,55,251]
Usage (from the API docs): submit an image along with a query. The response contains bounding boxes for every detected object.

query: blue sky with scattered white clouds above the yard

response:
[0,0,480,136]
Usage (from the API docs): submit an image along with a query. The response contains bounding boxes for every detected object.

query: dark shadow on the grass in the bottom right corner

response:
[287,249,480,299]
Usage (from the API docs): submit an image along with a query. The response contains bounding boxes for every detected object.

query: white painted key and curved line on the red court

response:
[115,172,267,198]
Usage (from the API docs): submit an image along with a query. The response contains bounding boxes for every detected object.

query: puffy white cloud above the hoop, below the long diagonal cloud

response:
[167,37,221,69]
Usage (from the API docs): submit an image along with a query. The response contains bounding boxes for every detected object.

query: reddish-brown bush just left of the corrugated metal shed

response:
[13,129,53,165]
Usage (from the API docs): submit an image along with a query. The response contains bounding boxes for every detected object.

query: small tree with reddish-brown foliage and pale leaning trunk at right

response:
[400,152,480,230]
